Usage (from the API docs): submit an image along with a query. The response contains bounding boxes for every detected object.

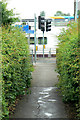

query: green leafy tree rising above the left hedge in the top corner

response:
[0,1,19,25]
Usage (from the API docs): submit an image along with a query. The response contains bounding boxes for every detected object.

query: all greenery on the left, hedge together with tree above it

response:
[0,0,32,119]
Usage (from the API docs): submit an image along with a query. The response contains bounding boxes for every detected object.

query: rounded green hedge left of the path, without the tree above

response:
[2,26,32,117]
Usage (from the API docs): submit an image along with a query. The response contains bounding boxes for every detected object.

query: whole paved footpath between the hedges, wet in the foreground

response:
[12,58,68,118]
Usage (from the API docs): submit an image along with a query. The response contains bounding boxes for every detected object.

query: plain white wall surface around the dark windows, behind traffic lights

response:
[30,21,67,54]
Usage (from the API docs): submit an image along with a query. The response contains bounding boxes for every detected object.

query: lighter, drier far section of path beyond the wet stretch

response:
[32,58,58,87]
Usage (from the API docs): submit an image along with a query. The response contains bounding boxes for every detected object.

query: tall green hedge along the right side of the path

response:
[57,22,80,115]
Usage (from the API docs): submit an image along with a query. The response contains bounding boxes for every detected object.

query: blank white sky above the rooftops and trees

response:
[7,0,74,19]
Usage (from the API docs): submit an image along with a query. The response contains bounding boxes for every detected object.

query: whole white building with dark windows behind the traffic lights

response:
[14,18,67,57]
